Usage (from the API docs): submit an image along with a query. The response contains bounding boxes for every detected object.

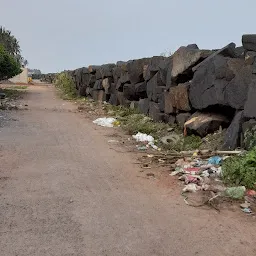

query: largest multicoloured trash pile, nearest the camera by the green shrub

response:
[170,152,256,214]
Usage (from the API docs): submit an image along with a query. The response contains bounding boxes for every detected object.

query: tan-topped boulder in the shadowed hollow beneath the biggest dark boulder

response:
[184,112,229,137]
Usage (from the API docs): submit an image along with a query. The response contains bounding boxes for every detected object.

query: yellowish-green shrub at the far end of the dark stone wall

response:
[54,72,77,100]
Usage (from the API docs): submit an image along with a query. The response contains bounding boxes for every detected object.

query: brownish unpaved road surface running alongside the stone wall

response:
[0,86,256,256]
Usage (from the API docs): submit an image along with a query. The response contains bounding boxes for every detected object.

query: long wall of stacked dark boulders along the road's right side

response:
[56,35,256,149]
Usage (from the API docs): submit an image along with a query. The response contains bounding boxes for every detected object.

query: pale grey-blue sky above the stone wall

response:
[0,0,256,73]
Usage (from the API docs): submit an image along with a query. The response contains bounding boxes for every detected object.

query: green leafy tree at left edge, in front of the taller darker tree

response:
[0,45,22,81]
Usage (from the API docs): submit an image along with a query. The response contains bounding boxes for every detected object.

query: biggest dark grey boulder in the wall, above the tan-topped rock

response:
[189,55,254,110]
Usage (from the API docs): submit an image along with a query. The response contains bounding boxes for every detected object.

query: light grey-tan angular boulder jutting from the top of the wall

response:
[171,46,212,82]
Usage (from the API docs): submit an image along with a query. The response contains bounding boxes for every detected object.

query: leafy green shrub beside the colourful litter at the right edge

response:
[222,147,256,189]
